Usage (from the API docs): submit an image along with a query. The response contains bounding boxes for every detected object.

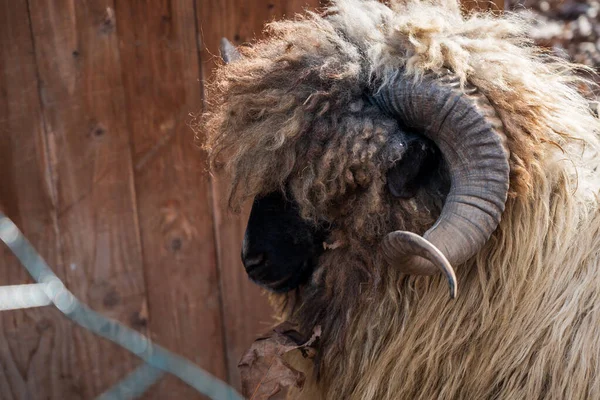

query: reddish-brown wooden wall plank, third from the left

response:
[115,0,226,399]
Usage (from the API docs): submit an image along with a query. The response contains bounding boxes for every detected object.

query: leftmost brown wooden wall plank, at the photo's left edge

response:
[0,0,76,400]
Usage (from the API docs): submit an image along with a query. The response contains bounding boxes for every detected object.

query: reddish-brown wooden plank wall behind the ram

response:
[0,0,499,400]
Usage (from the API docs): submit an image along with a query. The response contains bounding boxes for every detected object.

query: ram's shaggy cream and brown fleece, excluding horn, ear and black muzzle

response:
[198,0,600,400]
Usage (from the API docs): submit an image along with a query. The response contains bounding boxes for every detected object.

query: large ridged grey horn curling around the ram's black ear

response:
[374,71,510,298]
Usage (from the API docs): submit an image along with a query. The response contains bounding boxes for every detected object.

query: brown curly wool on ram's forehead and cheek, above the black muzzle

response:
[202,15,400,238]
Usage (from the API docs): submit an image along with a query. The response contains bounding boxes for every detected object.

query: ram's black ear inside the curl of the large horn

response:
[387,135,441,199]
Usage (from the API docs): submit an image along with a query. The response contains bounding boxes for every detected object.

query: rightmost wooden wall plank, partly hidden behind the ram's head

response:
[197,0,319,388]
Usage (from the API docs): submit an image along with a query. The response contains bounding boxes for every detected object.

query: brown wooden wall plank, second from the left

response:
[29,0,147,399]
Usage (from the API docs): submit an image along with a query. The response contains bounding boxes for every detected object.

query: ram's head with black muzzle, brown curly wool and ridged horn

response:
[216,38,510,295]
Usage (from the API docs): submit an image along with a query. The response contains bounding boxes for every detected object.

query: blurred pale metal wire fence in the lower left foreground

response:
[0,213,242,400]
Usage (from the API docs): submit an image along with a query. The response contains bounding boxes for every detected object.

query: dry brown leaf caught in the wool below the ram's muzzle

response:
[238,321,321,400]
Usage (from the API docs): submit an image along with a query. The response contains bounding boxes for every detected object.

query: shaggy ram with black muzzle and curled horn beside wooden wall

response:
[198,0,600,400]
